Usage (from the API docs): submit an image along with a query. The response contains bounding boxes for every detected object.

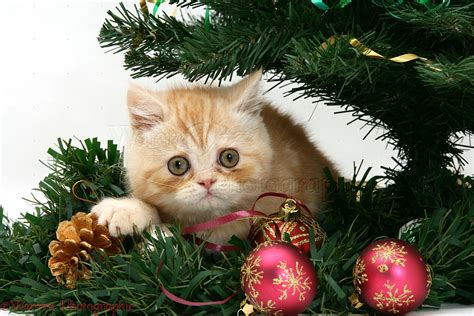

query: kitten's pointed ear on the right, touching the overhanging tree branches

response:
[227,69,262,114]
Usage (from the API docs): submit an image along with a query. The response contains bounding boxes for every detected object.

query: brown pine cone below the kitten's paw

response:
[48,212,121,288]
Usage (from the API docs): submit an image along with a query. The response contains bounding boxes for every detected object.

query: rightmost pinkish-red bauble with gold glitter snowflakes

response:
[353,238,431,314]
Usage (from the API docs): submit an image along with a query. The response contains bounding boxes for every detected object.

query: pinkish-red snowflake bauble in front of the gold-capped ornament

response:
[240,241,317,315]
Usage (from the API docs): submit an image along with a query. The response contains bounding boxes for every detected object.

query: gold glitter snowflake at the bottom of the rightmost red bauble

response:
[374,280,415,314]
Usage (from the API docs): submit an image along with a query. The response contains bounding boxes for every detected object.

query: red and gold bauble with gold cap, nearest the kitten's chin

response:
[249,199,326,253]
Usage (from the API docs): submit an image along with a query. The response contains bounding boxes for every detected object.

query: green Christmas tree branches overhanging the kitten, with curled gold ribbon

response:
[99,0,474,219]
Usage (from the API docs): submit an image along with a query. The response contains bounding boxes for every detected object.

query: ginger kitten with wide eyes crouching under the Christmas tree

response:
[92,72,335,244]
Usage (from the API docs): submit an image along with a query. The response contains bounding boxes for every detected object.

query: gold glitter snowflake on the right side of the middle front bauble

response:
[273,261,312,301]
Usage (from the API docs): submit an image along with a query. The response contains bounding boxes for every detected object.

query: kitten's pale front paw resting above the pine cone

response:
[91,198,161,237]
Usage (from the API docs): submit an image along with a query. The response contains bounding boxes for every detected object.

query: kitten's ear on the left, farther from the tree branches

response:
[127,84,163,131]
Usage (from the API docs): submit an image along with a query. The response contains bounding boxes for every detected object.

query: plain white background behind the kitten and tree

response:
[0,0,474,315]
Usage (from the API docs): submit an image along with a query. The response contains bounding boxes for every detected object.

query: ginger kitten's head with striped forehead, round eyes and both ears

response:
[127,76,273,222]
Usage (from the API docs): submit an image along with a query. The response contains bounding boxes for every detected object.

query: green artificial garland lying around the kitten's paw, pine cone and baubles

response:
[0,139,474,315]
